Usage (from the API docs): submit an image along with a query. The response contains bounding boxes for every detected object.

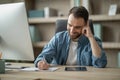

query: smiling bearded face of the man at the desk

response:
[67,14,85,41]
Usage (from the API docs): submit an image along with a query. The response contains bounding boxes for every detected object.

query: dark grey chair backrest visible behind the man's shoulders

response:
[55,19,94,35]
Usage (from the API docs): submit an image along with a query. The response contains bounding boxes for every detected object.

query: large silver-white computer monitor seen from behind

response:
[0,2,34,61]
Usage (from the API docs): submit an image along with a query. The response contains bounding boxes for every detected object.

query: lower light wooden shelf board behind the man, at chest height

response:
[33,41,120,49]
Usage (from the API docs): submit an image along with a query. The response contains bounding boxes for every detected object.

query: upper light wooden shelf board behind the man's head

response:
[28,14,120,24]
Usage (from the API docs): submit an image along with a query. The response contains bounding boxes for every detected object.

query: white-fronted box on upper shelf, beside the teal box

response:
[44,7,58,18]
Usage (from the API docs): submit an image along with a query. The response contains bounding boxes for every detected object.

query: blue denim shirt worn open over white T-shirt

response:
[34,31,107,68]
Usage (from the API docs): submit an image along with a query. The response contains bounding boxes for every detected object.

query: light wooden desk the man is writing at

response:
[0,63,120,80]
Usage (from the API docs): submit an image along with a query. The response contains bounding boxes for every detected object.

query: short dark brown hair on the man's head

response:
[68,6,89,23]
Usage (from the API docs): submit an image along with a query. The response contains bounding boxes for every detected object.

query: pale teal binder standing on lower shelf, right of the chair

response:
[93,24,102,40]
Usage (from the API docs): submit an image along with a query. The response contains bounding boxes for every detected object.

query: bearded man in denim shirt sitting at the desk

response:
[35,6,107,69]
